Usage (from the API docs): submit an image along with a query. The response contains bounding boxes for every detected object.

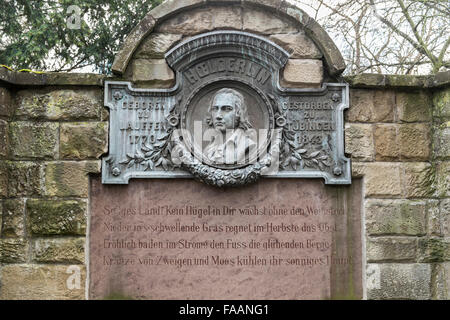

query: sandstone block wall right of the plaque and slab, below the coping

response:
[345,84,450,299]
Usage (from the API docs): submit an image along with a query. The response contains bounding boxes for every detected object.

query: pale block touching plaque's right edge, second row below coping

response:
[345,123,374,161]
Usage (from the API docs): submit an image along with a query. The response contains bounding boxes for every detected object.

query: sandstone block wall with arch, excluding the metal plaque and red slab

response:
[0,0,450,299]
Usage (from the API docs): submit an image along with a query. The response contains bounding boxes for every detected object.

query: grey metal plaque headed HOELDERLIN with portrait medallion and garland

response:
[102,31,351,187]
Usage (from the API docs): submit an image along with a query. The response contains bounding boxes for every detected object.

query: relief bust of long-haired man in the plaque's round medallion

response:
[203,88,257,165]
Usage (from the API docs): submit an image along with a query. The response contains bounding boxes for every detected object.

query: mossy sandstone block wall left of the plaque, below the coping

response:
[0,86,108,299]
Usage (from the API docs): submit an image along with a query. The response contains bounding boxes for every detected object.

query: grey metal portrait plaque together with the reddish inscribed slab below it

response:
[94,1,363,299]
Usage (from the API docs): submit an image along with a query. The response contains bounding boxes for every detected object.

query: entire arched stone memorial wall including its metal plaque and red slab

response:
[0,0,450,300]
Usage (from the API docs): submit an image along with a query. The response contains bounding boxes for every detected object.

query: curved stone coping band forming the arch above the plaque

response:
[112,0,345,76]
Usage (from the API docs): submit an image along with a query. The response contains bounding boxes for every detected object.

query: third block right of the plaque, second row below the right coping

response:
[399,124,431,160]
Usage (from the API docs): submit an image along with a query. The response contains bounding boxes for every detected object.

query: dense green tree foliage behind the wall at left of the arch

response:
[0,0,162,73]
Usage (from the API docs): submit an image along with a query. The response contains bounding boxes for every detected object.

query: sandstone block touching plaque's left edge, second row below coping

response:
[60,122,108,160]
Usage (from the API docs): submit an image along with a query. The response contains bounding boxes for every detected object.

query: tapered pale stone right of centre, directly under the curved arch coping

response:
[243,8,298,34]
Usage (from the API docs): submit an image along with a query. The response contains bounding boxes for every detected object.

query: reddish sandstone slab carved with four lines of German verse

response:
[89,178,362,299]
